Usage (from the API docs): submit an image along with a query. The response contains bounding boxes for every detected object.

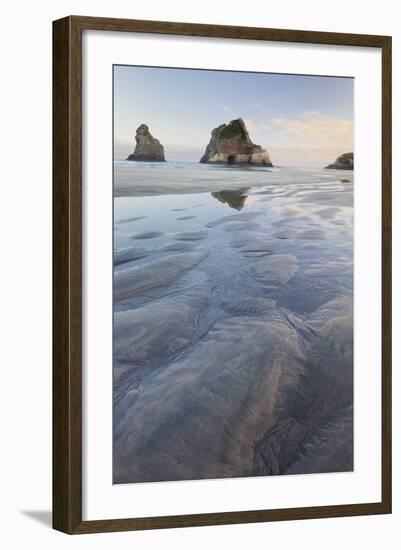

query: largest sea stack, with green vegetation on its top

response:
[199,118,273,166]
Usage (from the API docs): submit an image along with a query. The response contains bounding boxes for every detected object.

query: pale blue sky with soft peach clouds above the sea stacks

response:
[114,65,353,167]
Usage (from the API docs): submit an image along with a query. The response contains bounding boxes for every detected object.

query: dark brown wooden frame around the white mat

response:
[53,16,391,534]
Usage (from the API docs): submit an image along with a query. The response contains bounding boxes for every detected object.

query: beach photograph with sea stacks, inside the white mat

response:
[110,65,354,484]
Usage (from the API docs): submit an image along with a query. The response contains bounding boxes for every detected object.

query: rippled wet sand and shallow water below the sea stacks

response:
[113,162,353,483]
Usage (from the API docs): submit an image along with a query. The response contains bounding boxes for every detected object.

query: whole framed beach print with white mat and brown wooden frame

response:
[53,16,391,534]
